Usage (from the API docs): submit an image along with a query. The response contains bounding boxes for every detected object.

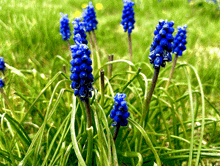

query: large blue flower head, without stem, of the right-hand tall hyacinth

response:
[149,20,175,69]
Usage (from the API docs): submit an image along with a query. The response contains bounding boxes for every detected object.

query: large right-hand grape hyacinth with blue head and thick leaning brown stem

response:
[141,20,175,131]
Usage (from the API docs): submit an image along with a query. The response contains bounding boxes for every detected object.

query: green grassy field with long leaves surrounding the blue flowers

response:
[0,0,220,165]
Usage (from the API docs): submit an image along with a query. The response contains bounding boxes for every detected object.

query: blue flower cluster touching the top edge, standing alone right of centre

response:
[121,0,135,34]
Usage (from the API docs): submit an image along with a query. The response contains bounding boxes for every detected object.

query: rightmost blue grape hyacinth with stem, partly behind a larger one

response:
[165,25,187,90]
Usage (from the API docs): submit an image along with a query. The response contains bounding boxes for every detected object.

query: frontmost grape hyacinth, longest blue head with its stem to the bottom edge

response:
[70,33,94,165]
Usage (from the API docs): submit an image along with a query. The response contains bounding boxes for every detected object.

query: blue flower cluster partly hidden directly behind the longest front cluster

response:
[72,17,88,44]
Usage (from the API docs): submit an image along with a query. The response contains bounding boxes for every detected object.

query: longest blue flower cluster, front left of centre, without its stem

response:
[70,34,94,101]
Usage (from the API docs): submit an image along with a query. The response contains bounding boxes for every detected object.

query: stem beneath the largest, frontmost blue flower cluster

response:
[84,97,93,165]
